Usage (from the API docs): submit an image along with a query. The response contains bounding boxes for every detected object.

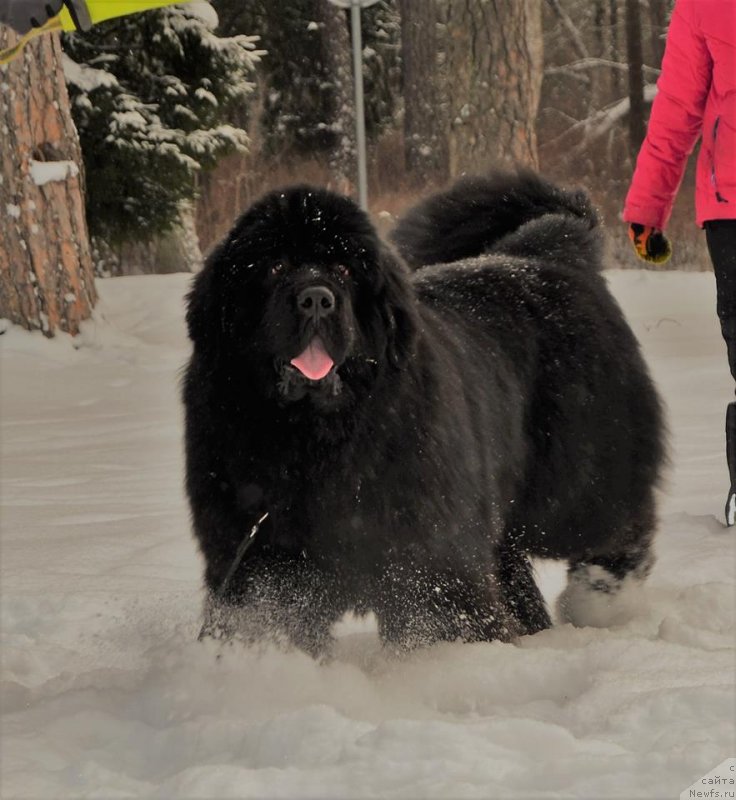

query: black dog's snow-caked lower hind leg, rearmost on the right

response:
[557,506,654,628]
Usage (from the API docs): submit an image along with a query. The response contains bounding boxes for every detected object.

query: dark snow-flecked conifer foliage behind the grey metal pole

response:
[214,0,400,161]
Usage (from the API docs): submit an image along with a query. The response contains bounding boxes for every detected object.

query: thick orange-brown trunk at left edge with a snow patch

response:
[0,26,97,336]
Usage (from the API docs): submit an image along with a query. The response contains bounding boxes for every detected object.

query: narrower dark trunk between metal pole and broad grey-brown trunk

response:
[399,0,449,186]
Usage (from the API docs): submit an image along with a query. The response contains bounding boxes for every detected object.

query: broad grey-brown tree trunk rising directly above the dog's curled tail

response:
[444,0,543,175]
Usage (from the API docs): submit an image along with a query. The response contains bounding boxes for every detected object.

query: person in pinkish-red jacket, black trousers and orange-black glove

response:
[623,0,736,525]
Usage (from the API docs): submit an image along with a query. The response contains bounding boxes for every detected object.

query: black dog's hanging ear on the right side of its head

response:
[379,248,419,369]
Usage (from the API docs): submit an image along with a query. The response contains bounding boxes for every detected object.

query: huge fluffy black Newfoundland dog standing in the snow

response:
[184,173,663,655]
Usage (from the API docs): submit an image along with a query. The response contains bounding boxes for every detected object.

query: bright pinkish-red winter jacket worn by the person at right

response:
[623,0,736,230]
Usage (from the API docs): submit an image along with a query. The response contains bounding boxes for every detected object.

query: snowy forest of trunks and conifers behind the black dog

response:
[0,0,708,336]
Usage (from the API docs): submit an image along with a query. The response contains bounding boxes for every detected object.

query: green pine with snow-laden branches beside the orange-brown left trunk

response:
[64,3,259,246]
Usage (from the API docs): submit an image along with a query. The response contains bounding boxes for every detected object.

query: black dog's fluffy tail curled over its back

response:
[392,170,602,271]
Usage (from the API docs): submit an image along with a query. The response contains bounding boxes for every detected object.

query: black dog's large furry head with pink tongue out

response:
[187,186,416,408]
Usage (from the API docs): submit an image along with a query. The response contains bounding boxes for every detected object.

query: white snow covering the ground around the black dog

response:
[0,271,736,798]
